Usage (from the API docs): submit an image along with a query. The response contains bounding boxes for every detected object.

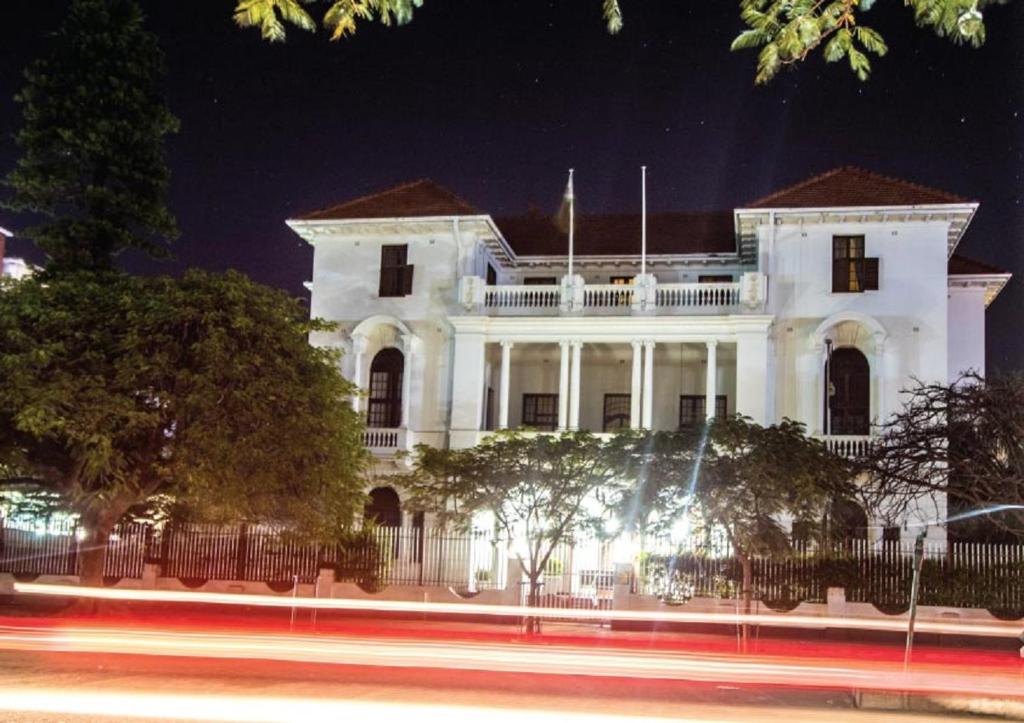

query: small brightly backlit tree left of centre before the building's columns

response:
[401,431,636,626]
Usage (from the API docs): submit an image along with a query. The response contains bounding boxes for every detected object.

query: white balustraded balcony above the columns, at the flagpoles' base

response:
[459,272,765,316]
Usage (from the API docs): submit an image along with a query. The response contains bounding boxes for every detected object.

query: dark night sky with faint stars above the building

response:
[0,0,1024,372]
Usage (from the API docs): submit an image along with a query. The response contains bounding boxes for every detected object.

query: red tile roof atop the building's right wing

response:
[746,166,967,208]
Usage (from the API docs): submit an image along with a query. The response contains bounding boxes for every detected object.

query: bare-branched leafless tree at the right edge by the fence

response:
[866,372,1024,536]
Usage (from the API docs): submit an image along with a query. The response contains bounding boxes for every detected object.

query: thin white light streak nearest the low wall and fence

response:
[14,583,1021,638]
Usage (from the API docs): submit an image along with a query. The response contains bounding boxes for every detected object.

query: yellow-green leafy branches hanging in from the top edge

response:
[234,0,1008,84]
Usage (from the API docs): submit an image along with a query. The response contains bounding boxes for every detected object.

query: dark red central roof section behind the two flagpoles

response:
[495,211,736,256]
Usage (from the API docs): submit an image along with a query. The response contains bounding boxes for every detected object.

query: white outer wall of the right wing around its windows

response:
[759,221,948,431]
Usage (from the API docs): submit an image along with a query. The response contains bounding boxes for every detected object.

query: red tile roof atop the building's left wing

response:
[300,178,482,221]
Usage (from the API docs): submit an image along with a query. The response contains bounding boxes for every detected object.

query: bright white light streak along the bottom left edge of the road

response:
[0,688,722,723]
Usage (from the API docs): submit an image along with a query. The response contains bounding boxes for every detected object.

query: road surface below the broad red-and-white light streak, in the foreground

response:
[0,651,999,723]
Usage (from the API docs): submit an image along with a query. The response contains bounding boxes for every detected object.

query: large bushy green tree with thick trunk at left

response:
[0,271,366,585]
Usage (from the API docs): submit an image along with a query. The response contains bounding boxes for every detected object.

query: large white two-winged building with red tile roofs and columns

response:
[288,168,1010,540]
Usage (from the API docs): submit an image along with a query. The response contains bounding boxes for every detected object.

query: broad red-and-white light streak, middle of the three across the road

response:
[0,627,1024,697]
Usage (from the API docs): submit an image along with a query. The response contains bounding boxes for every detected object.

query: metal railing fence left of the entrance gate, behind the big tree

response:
[0,520,508,591]
